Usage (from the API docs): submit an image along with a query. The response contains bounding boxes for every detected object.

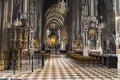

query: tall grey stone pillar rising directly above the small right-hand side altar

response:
[72,0,80,49]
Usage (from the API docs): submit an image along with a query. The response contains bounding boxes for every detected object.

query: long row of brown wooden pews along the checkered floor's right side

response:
[67,50,118,68]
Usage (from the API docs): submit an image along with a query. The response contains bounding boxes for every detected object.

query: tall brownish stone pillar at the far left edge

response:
[1,0,8,68]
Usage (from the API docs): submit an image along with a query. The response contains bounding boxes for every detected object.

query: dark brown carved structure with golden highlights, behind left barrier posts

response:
[8,22,28,68]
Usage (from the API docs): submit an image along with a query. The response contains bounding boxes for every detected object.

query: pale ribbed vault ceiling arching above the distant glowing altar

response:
[45,3,65,28]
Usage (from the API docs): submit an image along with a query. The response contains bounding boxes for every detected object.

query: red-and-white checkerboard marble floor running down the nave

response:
[0,55,120,80]
